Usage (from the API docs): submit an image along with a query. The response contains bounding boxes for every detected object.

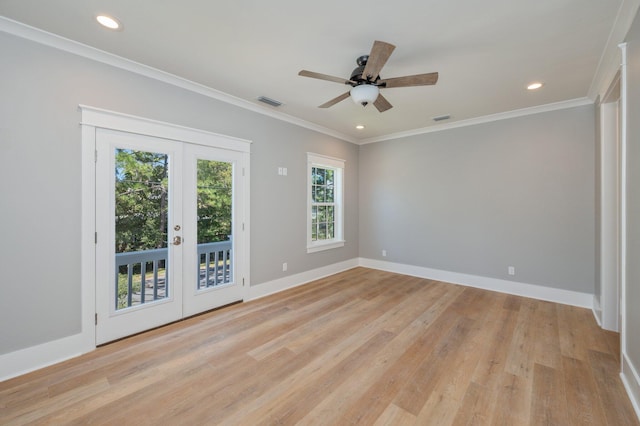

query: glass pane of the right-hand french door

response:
[196,159,233,290]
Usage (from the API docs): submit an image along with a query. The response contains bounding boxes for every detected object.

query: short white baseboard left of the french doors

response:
[0,333,96,382]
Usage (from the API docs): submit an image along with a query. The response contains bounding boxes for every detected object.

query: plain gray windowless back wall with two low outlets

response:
[359,106,595,293]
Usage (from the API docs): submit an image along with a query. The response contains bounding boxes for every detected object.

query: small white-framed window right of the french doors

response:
[307,153,344,253]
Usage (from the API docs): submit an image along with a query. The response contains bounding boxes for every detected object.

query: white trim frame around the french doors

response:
[79,105,251,347]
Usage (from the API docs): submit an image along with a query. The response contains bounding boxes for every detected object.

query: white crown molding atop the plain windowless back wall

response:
[359,98,593,145]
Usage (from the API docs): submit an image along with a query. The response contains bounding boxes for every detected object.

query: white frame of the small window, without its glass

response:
[307,152,345,253]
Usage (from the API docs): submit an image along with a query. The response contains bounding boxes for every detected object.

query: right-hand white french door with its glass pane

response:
[182,144,246,316]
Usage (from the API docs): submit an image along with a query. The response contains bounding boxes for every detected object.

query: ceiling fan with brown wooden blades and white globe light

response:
[298,40,438,112]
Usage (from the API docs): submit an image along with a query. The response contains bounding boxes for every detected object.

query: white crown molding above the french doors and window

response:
[0,16,359,144]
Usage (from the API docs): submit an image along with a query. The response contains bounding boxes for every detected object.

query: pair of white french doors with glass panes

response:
[95,128,246,344]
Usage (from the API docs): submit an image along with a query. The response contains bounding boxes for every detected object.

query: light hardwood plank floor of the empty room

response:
[0,268,640,426]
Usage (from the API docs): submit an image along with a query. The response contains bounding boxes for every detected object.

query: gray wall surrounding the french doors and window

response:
[0,33,358,354]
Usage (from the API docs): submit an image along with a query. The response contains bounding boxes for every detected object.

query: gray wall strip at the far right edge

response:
[623,6,640,386]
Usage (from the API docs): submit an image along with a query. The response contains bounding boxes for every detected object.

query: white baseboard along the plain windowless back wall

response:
[359,258,593,309]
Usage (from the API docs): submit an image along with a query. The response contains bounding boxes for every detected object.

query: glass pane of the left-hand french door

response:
[115,149,169,310]
